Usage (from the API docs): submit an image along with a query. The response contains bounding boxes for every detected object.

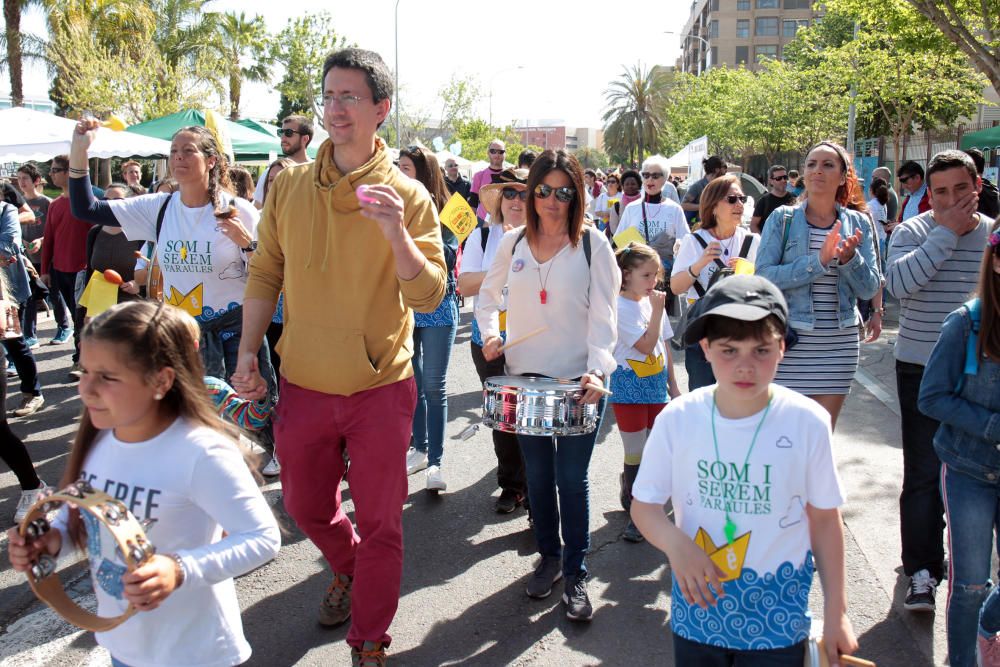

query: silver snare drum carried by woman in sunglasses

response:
[483,375,598,435]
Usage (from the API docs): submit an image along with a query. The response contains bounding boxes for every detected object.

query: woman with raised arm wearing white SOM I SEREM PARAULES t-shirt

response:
[69,119,277,408]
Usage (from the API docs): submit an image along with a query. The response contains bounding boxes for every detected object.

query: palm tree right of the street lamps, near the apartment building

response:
[604,64,671,162]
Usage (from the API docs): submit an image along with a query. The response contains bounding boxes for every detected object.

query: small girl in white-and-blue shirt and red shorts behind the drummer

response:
[610,243,680,542]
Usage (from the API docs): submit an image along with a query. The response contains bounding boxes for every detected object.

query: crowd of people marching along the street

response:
[0,43,1000,667]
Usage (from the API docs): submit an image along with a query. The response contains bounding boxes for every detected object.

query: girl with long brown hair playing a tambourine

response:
[8,301,280,667]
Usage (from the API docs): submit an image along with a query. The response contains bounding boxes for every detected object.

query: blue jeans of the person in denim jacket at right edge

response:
[941,465,1000,667]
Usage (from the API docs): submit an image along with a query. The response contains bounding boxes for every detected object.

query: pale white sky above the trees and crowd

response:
[7,0,690,127]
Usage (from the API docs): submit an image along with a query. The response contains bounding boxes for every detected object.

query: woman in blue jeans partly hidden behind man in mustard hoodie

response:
[399,146,458,492]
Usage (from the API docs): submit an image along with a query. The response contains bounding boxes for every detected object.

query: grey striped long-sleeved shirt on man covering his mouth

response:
[886,211,993,366]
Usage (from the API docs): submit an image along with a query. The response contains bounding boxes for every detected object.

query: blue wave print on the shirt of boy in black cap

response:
[670,552,814,651]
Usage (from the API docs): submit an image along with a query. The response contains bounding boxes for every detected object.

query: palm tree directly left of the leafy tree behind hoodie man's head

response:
[216,12,271,120]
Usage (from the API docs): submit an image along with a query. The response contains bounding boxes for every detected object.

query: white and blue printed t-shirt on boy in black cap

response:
[632,384,844,650]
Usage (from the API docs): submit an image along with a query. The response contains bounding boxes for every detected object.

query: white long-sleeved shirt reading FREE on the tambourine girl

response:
[54,419,281,667]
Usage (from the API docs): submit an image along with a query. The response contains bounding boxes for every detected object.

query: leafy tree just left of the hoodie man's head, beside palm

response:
[271,12,350,124]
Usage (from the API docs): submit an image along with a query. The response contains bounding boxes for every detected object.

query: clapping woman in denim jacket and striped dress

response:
[757,141,882,427]
